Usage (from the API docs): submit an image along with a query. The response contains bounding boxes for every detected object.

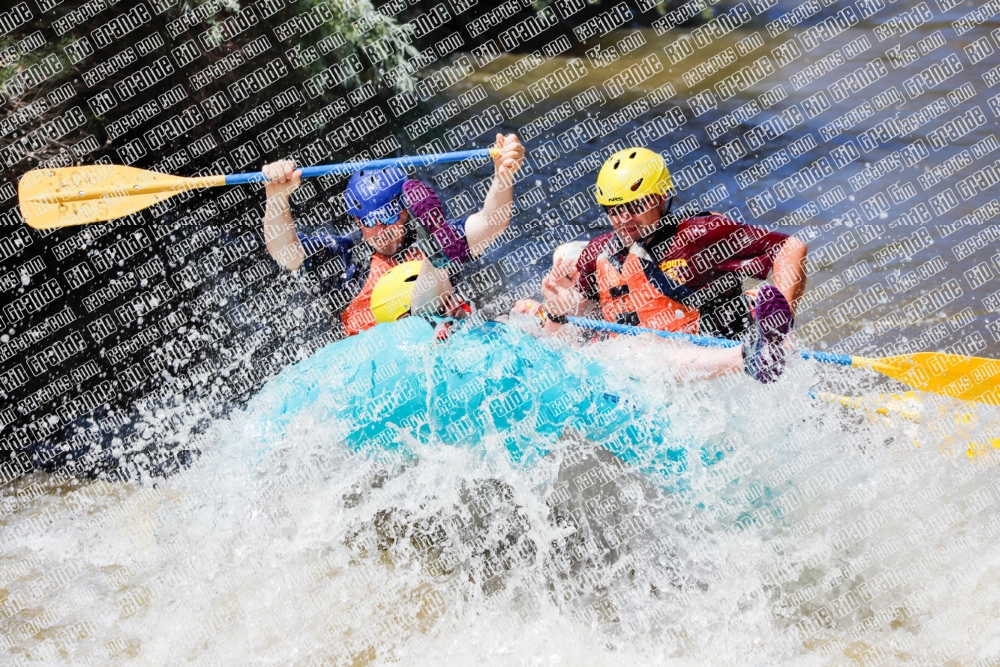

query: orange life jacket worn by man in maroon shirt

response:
[596,245,698,333]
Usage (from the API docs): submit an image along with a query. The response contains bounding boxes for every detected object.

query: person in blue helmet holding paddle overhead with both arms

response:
[262,134,524,336]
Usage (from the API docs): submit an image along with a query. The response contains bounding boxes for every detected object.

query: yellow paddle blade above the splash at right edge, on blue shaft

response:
[853,352,1000,405]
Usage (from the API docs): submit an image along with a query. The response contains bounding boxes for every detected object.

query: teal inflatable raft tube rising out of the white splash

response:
[244,317,723,491]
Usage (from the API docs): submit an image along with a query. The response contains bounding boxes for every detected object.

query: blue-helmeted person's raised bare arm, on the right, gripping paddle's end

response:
[465,134,524,257]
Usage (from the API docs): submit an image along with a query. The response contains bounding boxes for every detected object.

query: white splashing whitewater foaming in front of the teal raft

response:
[0,320,1000,665]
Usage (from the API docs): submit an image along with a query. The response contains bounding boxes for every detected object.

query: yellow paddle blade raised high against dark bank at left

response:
[18,164,226,229]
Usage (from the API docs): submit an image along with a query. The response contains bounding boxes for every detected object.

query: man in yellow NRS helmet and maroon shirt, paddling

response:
[515,147,807,382]
